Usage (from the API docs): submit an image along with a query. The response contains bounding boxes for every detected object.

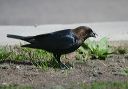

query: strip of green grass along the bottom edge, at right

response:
[66,81,128,89]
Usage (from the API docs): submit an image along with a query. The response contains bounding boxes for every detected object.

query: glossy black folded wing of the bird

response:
[31,29,76,49]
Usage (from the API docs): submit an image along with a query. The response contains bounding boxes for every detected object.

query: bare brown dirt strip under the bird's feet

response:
[0,41,128,89]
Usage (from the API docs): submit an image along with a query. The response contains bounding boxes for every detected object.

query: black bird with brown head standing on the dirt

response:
[7,26,97,69]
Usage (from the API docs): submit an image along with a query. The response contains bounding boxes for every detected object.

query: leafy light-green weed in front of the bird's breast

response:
[79,37,112,59]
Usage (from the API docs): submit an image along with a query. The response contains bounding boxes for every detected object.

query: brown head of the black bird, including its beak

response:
[73,26,97,40]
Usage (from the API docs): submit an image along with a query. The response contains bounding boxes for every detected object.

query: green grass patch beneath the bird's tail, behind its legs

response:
[0,46,58,69]
